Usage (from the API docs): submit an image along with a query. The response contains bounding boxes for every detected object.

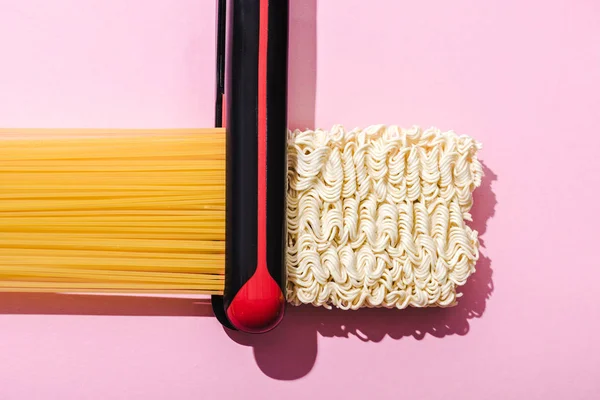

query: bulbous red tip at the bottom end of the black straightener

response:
[227,269,285,333]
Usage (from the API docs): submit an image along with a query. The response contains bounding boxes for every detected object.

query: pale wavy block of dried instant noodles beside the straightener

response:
[287,125,483,309]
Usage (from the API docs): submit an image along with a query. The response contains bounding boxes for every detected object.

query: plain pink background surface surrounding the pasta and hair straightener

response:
[0,0,600,400]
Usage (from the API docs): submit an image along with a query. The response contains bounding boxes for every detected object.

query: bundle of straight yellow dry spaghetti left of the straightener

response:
[0,129,225,294]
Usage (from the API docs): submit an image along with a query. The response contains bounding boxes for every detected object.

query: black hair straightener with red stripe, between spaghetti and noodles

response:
[212,0,289,333]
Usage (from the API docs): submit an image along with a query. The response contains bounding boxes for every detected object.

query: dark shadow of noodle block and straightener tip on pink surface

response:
[226,165,497,380]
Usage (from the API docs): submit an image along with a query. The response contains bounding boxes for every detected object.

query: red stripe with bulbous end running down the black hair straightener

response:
[227,0,285,333]
